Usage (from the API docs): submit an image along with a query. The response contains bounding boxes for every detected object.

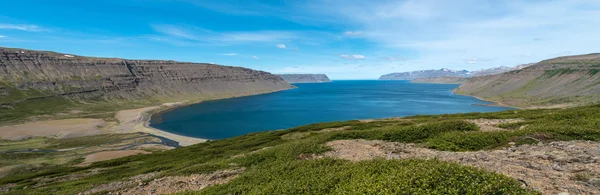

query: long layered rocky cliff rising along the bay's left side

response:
[0,48,291,104]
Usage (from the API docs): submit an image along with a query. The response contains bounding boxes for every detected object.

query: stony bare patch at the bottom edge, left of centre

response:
[89,169,244,195]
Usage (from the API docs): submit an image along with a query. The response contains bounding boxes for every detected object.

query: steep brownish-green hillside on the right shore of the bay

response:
[455,54,600,107]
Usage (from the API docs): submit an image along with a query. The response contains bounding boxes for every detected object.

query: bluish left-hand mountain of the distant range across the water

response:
[379,68,471,80]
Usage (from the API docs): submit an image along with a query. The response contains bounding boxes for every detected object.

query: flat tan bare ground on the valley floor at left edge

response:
[0,118,107,141]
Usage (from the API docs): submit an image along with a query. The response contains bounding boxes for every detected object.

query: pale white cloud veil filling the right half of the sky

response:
[300,0,600,70]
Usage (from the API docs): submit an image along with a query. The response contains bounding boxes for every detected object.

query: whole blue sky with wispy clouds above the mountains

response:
[0,0,600,79]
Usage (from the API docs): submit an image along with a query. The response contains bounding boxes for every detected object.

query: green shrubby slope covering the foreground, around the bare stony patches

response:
[0,105,600,194]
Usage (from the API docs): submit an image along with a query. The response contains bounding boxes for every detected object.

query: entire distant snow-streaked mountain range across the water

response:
[379,64,532,80]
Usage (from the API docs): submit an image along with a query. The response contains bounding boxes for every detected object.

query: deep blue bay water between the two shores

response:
[150,80,509,139]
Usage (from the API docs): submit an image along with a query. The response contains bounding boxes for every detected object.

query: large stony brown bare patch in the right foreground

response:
[325,140,600,194]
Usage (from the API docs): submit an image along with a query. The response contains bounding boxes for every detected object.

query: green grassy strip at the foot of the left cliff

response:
[0,78,272,126]
